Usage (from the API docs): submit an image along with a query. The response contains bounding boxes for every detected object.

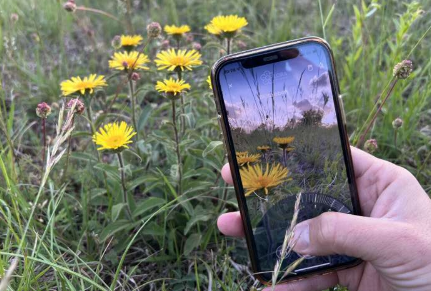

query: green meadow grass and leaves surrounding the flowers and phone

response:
[0,0,431,291]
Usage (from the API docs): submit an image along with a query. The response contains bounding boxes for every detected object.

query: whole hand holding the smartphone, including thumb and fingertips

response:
[217,147,431,291]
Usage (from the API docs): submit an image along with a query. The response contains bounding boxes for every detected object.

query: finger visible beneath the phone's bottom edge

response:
[264,273,338,291]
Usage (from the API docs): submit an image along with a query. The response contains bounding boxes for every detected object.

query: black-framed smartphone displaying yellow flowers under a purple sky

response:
[211,37,361,283]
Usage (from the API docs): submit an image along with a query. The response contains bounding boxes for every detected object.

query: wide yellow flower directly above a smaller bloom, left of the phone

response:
[155,49,202,71]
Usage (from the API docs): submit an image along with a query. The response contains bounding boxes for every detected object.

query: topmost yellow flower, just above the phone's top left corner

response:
[205,15,248,37]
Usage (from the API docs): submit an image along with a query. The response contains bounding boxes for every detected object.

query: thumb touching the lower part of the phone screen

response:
[293,212,405,261]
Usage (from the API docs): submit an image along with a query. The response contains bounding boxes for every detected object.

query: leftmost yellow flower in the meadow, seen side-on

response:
[60,74,107,96]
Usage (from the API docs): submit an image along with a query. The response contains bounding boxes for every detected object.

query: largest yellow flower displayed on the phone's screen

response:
[240,164,291,196]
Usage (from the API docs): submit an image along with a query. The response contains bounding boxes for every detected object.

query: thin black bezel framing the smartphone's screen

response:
[211,37,362,285]
